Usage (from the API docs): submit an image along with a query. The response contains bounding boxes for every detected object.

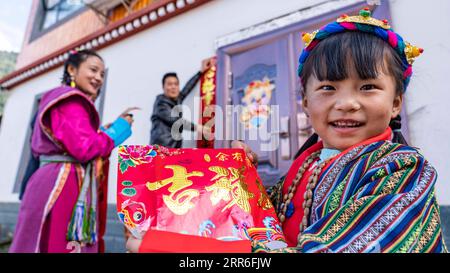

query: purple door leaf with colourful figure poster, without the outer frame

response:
[228,36,293,185]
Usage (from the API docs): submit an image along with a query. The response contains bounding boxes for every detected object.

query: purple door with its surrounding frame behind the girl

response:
[216,1,398,186]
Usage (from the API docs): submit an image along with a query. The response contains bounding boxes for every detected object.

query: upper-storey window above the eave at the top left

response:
[41,0,84,30]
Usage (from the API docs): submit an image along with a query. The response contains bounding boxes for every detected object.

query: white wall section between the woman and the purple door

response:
[94,0,326,203]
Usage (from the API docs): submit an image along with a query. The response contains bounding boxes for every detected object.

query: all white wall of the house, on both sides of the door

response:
[0,0,450,205]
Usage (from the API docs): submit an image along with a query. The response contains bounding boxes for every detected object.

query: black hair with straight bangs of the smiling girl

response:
[296,31,408,157]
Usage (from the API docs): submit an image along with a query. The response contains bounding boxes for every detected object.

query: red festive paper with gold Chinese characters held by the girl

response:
[117,145,285,252]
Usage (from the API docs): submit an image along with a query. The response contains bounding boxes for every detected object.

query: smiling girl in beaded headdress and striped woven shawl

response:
[237,9,447,252]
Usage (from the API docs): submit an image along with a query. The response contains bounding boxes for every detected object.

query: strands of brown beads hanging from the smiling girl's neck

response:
[278,151,328,232]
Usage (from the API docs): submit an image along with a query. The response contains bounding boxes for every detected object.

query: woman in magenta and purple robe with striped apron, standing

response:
[10,50,133,253]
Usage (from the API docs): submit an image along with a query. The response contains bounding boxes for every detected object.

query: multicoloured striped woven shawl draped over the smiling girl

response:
[264,141,447,253]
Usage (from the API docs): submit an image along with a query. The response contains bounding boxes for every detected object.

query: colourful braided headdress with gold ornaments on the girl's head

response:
[298,8,423,90]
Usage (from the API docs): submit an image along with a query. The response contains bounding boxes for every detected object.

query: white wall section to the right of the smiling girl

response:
[390,0,450,205]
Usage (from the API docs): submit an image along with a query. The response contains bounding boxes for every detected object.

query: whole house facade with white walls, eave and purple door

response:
[0,0,450,252]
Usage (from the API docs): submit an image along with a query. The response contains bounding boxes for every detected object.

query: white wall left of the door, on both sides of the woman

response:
[0,0,327,203]
